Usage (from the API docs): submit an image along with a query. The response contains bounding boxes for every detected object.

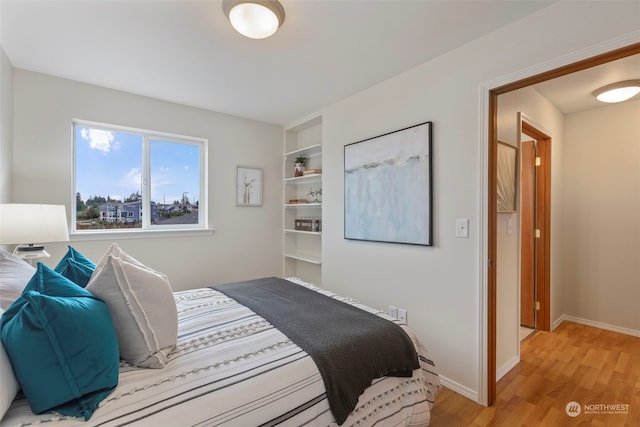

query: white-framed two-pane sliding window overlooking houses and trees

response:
[73,121,207,233]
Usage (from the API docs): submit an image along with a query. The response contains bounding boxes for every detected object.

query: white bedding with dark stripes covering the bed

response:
[0,278,440,427]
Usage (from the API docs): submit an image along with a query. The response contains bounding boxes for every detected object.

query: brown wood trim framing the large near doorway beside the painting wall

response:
[486,43,640,405]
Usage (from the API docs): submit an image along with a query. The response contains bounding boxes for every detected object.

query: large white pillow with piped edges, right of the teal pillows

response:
[86,243,178,368]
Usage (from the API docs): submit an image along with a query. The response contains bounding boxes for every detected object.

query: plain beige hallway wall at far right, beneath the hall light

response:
[558,100,640,336]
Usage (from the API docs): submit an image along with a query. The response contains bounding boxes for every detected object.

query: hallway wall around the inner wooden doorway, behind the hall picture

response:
[496,87,564,374]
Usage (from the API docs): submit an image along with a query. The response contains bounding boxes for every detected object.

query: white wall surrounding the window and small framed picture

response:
[12,69,283,290]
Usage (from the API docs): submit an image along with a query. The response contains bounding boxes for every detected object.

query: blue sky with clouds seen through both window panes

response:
[75,125,200,203]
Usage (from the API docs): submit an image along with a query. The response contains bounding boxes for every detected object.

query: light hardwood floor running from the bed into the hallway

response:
[431,322,640,427]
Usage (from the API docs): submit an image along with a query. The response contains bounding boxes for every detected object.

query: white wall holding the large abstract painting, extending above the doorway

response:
[322,2,640,401]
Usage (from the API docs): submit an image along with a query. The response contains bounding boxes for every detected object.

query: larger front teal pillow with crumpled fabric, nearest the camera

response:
[0,263,120,420]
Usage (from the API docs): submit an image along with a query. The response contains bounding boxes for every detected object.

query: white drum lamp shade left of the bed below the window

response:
[0,203,69,245]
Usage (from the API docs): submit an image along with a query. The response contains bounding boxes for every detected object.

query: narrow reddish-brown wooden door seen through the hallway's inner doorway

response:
[520,141,536,328]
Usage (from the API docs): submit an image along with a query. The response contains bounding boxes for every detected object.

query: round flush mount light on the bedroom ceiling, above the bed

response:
[222,0,284,39]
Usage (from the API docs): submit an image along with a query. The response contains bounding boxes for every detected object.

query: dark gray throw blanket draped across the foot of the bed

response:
[212,277,419,424]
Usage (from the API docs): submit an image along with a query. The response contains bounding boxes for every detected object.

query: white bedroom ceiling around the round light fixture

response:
[0,0,555,124]
